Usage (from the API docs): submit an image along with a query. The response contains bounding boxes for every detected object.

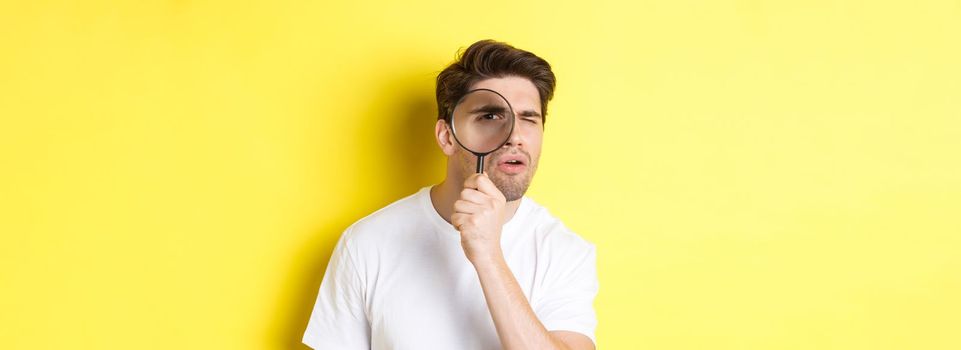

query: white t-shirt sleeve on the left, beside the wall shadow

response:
[303,229,370,350]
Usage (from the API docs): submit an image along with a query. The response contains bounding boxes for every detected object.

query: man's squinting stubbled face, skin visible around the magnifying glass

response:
[451,76,544,201]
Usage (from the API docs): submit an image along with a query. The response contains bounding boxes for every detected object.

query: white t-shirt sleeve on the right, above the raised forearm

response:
[533,243,598,344]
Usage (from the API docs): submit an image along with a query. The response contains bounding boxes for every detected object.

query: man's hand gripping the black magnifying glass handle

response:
[451,174,507,265]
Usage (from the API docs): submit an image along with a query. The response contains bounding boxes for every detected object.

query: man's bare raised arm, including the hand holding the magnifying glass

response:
[451,175,594,350]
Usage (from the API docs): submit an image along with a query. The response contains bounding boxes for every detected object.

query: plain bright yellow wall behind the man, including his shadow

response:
[0,0,961,349]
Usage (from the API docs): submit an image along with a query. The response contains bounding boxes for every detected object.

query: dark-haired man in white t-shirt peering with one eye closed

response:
[303,40,598,350]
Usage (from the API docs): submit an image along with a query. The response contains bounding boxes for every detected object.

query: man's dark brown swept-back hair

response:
[437,40,557,122]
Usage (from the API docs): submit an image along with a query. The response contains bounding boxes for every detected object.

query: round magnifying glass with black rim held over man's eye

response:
[450,89,514,173]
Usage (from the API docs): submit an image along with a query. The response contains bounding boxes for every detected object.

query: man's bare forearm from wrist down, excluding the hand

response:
[474,254,570,350]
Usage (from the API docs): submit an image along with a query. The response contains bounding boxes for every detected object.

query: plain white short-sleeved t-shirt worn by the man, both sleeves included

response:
[303,187,598,349]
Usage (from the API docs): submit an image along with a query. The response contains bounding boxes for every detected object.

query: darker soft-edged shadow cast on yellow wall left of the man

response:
[269,68,444,348]
